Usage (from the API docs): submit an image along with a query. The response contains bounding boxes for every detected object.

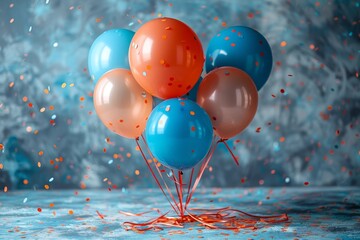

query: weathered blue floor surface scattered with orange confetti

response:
[0,187,360,240]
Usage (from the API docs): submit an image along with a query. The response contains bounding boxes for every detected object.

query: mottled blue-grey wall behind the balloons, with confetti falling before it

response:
[0,0,360,191]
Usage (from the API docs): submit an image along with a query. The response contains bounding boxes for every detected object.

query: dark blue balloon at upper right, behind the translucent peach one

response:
[206,26,273,90]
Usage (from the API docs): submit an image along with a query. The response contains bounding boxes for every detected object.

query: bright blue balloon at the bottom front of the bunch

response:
[145,98,213,170]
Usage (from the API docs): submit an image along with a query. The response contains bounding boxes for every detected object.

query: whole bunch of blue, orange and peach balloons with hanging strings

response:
[88,18,282,231]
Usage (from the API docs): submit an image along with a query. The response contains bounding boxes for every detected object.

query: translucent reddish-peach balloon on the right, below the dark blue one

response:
[197,67,258,139]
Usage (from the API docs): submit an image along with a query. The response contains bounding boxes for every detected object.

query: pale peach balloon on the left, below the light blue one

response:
[94,68,152,138]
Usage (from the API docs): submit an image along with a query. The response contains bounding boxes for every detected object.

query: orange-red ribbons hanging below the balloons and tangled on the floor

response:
[125,136,289,233]
